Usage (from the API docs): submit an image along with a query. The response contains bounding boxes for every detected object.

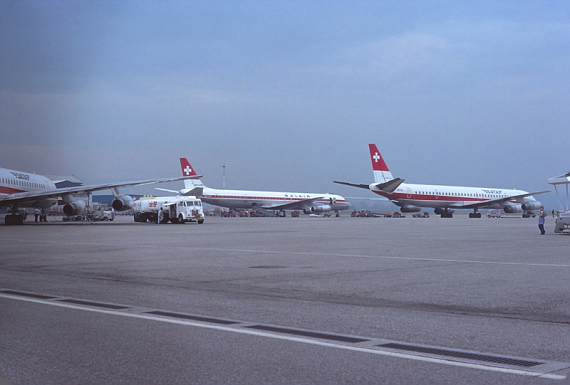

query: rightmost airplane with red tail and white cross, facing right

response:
[334,144,550,218]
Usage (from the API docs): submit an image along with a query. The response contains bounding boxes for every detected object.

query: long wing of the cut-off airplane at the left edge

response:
[0,175,201,204]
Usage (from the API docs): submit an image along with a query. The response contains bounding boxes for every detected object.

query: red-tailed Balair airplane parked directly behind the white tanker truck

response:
[172,158,350,217]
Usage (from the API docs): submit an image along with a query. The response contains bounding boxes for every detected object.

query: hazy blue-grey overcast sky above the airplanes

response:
[0,0,570,207]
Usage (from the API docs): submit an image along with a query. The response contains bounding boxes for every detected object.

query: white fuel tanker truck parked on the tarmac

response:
[133,196,204,224]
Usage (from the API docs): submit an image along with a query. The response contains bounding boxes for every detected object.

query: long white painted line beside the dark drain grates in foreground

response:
[0,293,566,380]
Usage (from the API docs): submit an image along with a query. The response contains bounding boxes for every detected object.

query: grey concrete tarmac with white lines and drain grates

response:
[0,214,570,385]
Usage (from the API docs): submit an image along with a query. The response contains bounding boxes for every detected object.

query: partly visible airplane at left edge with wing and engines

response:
[0,164,199,225]
